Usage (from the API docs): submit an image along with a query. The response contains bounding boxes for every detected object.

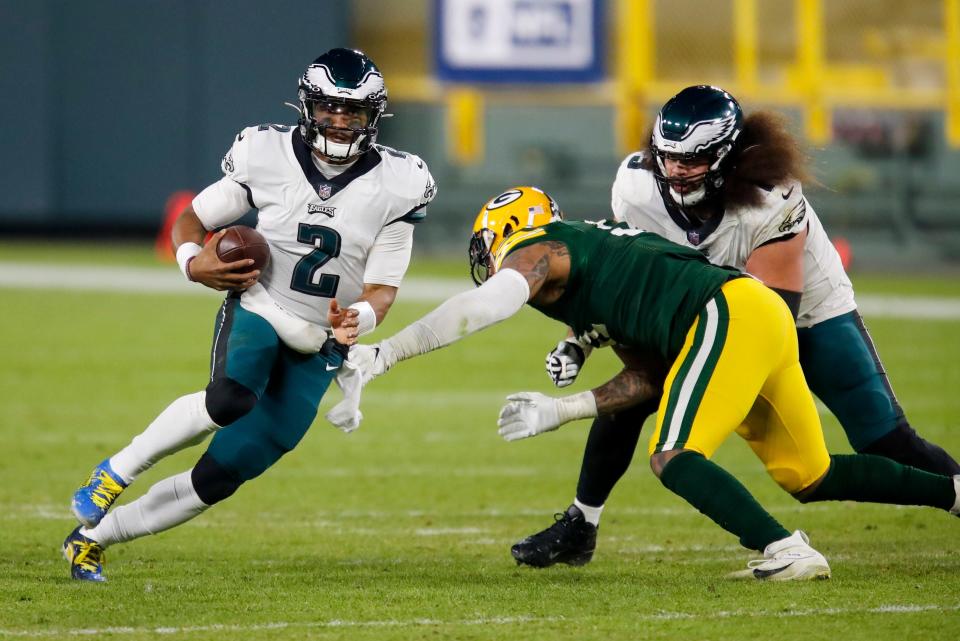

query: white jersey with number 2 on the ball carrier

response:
[194,125,436,327]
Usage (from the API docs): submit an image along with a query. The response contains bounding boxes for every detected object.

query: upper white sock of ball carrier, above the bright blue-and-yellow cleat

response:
[110,392,220,485]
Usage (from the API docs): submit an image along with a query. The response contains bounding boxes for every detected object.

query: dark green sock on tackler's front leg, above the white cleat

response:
[660,452,790,551]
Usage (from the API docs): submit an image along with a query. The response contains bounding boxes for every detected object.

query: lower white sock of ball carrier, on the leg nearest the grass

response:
[80,470,210,547]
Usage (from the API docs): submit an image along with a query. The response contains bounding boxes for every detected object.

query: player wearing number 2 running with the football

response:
[63,49,436,581]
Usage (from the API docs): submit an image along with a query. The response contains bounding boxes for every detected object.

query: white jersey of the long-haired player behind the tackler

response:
[611,153,856,327]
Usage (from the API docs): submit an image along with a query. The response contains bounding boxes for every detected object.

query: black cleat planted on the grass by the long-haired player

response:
[510,505,597,568]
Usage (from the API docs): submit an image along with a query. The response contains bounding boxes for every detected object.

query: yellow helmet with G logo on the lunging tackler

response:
[470,187,563,287]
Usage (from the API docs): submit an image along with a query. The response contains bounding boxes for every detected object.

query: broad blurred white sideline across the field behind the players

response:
[0,261,960,320]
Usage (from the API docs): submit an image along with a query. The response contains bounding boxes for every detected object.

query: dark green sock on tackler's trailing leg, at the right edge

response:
[800,454,957,510]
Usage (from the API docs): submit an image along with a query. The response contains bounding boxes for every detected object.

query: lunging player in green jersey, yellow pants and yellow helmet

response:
[350,187,960,580]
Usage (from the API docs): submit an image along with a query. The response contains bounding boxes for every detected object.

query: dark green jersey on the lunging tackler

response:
[497,221,742,361]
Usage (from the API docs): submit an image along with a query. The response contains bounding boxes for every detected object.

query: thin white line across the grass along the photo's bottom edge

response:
[0,603,960,638]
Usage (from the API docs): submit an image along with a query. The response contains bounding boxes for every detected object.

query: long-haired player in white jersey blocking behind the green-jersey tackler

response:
[511,85,960,567]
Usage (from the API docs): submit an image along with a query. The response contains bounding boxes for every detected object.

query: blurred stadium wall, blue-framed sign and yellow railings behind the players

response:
[0,0,960,271]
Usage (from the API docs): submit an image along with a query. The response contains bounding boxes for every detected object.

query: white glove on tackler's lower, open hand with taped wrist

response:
[497,392,597,441]
